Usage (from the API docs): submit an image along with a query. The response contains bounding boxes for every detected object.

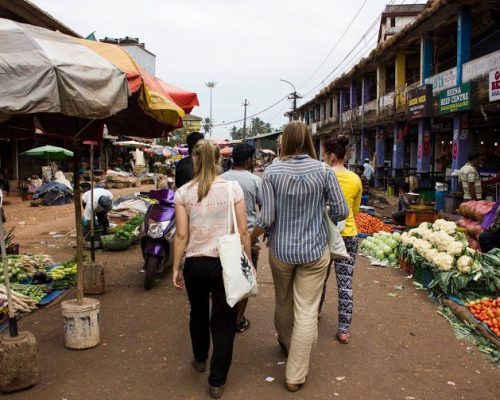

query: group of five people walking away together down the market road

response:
[172,121,362,398]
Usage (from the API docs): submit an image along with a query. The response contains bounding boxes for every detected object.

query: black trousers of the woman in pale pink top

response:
[184,257,237,386]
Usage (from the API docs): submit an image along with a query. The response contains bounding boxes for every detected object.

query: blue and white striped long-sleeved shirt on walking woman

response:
[257,155,349,264]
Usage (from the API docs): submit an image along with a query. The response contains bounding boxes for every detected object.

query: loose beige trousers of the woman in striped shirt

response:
[269,248,330,384]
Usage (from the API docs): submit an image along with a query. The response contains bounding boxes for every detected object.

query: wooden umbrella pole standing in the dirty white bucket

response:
[73,139,83,305]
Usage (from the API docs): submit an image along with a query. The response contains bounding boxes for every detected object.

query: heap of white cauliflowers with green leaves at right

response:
[398,219,500,293]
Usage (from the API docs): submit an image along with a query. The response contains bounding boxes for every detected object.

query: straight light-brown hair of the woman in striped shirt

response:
[280,121,316,160]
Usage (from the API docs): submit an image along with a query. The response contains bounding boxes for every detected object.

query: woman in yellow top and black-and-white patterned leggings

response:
[320,136,363,344]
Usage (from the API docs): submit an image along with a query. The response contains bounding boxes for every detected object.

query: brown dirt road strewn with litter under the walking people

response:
[0,191,500,400]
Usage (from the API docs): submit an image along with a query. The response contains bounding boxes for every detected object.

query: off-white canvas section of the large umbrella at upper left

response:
[0,18,129,120]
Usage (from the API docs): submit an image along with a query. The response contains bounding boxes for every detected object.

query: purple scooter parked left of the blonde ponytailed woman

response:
[141,189,175,290]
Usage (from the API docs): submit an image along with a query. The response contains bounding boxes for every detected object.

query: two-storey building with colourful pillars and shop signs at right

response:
[299,0,500,195]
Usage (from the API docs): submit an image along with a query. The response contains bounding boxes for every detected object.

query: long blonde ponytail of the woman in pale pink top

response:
[192,139,219,202]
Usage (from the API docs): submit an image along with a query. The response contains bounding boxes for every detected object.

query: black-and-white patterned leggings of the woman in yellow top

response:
[319,236,358,333]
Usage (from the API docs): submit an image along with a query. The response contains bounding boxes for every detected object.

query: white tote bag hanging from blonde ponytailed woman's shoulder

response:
[218,182,257,307]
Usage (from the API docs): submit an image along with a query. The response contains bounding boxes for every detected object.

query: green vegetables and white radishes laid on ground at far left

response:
[0,254,76,314]
